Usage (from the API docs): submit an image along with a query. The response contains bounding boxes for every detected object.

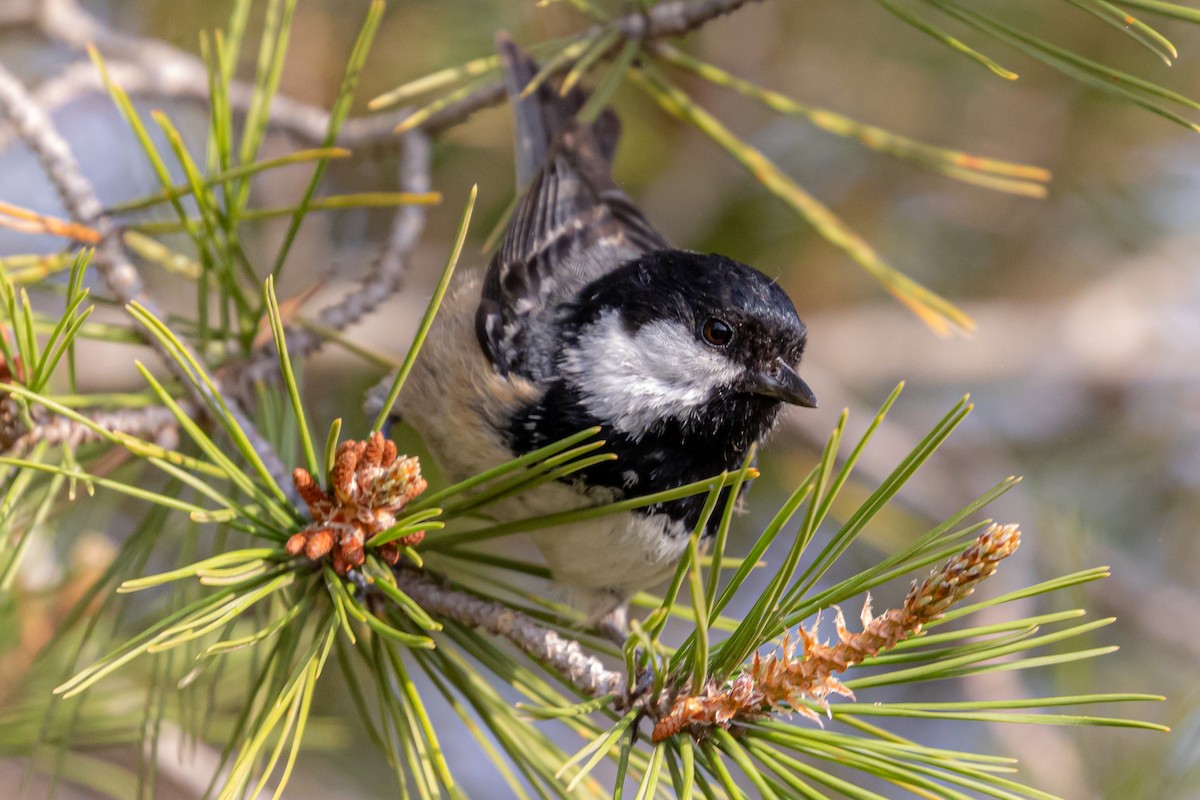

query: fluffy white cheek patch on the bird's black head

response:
[563,311,742,439]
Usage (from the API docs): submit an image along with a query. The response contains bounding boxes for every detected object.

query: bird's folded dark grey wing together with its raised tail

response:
[475,35,668,380]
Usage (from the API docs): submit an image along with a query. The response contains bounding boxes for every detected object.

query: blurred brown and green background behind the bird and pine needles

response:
[0,0,1200,799]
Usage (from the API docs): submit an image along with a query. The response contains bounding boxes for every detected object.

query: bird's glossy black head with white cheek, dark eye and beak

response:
[559,251,816,439]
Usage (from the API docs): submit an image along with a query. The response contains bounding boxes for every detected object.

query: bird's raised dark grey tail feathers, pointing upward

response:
[496,31,620,187]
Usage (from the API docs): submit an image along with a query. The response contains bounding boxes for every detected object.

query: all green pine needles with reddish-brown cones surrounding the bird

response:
[0,0,1200,798]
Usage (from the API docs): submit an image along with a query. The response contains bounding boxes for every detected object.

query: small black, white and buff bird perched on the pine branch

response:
[388,32,817,638]
